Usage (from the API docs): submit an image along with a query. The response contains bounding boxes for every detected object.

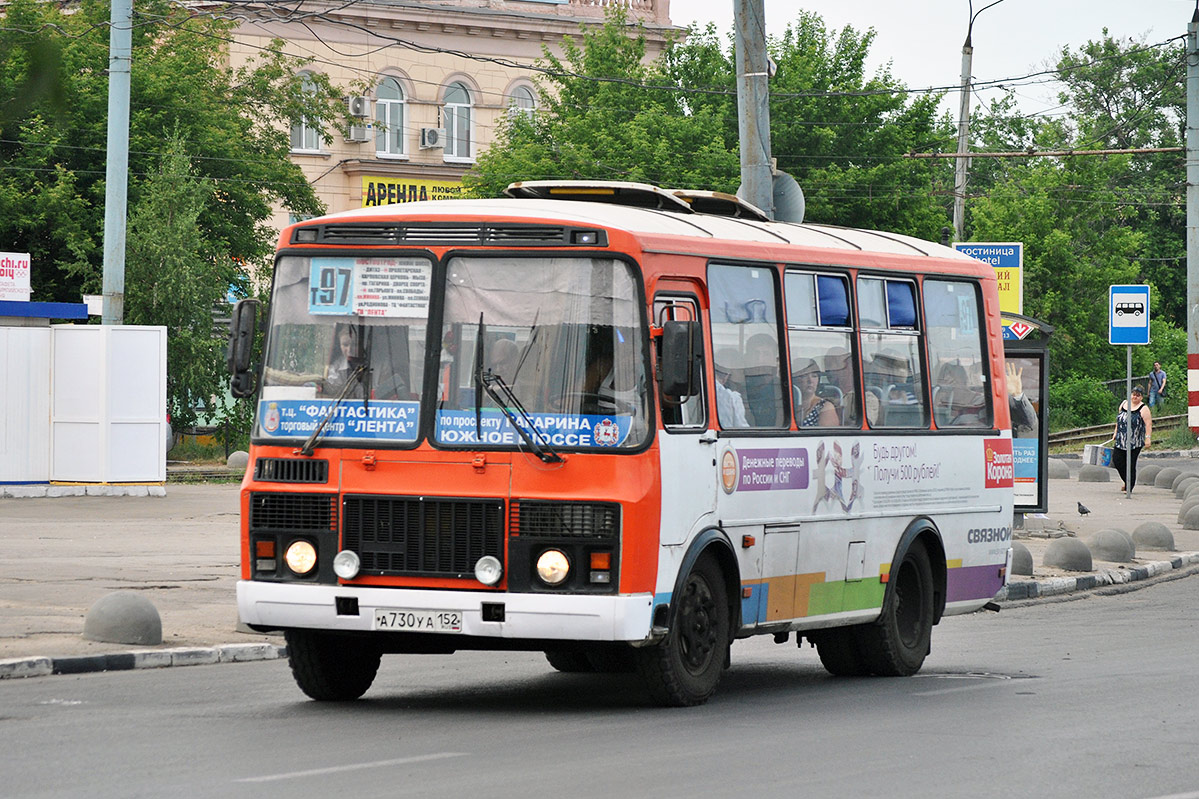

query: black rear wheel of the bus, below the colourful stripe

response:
[855,541,935,677]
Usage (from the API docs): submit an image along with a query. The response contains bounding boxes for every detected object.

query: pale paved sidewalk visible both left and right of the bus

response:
[0,452,1199,679]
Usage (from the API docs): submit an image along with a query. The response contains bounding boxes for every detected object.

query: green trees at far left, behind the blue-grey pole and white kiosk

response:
[0,0,344,427]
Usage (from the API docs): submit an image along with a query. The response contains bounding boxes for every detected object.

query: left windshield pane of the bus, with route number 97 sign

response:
[255,256,433,445]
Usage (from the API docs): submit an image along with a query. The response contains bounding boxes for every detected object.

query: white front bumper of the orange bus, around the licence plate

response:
[237,579,653,642]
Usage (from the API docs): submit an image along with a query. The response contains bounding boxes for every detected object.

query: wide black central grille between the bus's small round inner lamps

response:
[342,497,504,577]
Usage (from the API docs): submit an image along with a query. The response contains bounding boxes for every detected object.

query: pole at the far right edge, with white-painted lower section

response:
[1187,5,1199,433]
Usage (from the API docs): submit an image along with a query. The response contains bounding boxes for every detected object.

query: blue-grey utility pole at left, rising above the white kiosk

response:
[101,0,133,325]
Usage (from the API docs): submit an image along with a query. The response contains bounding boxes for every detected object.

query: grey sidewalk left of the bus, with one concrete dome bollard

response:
[0,482,282,678]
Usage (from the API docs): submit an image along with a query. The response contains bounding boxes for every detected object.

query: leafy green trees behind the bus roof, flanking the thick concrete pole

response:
[465,11,952,239]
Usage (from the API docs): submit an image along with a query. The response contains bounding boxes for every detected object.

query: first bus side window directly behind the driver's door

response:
[707,264,790,428]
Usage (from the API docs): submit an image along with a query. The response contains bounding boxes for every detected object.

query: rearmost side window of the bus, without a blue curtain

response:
[924,280,992,427]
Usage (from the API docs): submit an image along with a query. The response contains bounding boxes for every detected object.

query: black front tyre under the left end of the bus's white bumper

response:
[285,630,382,702]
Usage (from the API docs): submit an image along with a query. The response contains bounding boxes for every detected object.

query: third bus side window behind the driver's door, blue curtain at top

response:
[857,277,928,427]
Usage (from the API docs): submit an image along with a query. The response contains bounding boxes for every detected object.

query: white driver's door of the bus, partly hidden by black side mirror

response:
[653,292,717,546]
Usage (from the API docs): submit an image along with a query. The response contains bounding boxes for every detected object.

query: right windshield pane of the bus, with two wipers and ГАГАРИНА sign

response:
[434,256,649,449]
